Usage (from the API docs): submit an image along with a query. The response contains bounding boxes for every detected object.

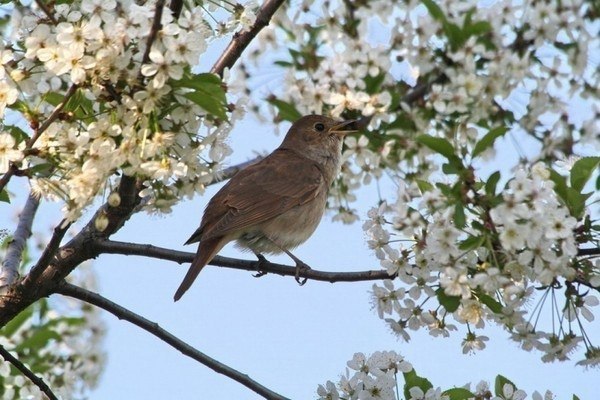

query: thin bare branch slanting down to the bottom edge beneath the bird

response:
[56,281,286,400]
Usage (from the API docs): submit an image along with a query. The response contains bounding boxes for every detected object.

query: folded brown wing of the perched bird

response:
[188,149,327,243]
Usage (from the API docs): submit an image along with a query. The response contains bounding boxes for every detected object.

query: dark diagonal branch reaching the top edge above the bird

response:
[210,0,285,77]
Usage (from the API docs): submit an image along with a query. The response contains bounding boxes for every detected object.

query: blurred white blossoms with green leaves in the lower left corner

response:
[0,266,106,400]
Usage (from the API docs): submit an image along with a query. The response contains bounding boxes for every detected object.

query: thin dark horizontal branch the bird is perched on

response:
[92,240,395,283]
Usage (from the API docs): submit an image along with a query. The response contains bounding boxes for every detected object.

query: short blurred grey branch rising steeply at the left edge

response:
[0,193,40,290]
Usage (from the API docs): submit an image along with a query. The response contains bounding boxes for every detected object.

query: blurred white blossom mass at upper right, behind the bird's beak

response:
[241,0,600,222]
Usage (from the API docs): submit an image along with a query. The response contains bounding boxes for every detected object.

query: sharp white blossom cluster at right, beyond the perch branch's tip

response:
[363,163,600,365]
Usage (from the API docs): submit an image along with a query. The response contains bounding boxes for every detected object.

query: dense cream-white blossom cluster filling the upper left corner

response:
[0,0,255,221]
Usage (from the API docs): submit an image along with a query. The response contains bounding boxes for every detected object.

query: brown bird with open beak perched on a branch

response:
[174,115,356,301]
